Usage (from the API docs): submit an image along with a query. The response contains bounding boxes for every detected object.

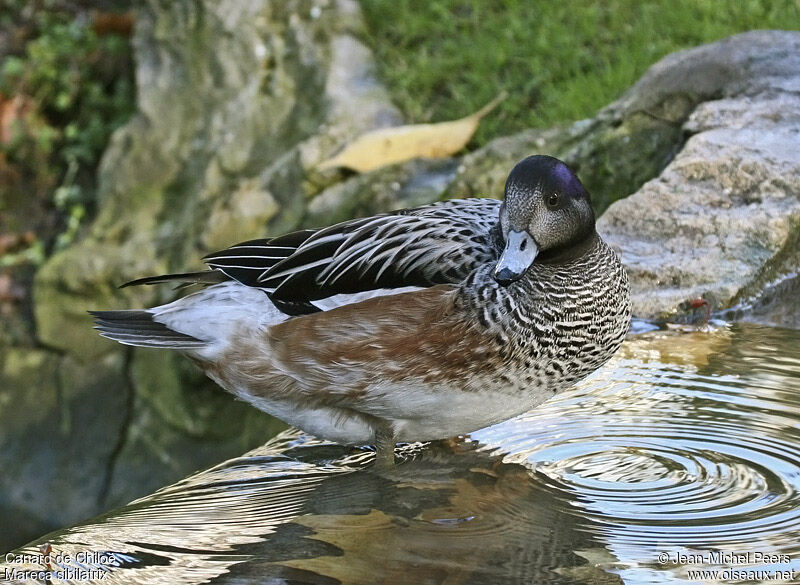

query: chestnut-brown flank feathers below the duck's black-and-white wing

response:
[262,285,488,402]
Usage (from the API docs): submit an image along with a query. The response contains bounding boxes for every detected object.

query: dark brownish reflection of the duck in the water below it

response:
[220,442,604,584]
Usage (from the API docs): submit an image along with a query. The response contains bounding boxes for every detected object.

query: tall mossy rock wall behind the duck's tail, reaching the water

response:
[9,0,402,546]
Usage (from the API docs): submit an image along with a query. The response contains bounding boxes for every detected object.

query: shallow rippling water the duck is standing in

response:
[0,325,800,584]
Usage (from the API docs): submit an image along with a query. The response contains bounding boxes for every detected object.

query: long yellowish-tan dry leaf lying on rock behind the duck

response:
[318,92,506,173]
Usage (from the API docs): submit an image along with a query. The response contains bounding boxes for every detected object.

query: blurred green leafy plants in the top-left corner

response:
[0,0,135,264]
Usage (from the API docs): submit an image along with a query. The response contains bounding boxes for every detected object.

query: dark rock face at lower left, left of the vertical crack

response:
[0,348,128,550]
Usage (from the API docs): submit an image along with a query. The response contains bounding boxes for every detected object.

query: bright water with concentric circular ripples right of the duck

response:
[473,326,800,564]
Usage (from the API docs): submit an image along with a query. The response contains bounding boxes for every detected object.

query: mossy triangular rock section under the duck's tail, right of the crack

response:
[102,350,286,508]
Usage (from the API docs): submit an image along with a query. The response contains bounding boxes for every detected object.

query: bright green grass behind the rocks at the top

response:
[361,0,800,147]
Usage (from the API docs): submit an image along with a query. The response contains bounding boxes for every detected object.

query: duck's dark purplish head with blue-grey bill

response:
[494,155,596,286]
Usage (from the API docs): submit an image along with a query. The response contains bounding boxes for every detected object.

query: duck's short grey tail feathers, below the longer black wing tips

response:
[89,310,206,350]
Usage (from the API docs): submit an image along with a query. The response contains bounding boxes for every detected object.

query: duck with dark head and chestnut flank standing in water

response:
[89,155,631,467]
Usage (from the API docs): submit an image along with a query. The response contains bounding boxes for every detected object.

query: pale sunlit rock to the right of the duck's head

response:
[598,31,800,326]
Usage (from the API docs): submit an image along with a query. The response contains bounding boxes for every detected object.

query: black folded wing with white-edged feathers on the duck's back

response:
[206,199,502,302]
